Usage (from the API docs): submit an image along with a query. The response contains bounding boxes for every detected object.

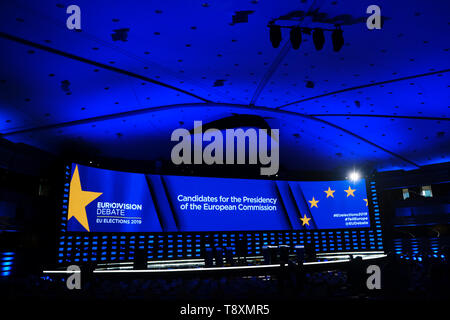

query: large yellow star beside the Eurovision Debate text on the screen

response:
[67,166,103,231]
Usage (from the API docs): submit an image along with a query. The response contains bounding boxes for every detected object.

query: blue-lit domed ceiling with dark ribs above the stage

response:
[0,0,450,170]
